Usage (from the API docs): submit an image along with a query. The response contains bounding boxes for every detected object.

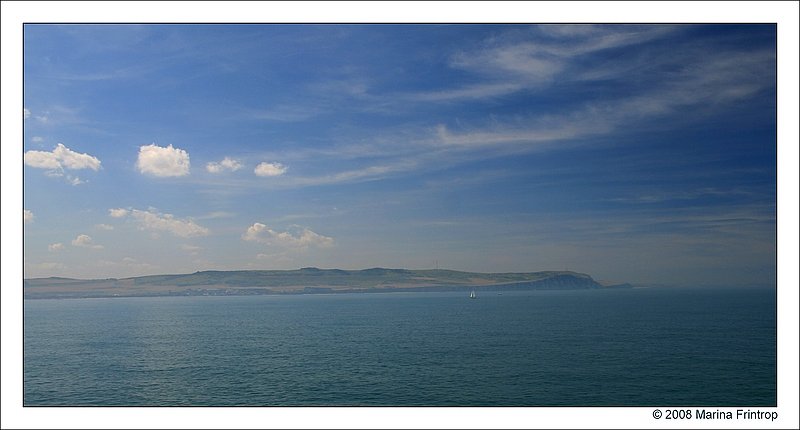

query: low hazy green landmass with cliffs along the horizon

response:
[23,267,630,299]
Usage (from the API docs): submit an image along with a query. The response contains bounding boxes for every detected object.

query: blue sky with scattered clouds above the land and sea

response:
[22,24,777,285]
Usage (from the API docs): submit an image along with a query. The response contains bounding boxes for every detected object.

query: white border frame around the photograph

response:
[0,1,800,428]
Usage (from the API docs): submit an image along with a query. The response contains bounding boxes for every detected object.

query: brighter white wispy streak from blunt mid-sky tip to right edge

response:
[436,45,774,153]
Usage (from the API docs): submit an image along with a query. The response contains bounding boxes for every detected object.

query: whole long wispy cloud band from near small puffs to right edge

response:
[211,46,774,187]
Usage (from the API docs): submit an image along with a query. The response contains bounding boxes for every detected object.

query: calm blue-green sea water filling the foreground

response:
[23,288,777,406]
